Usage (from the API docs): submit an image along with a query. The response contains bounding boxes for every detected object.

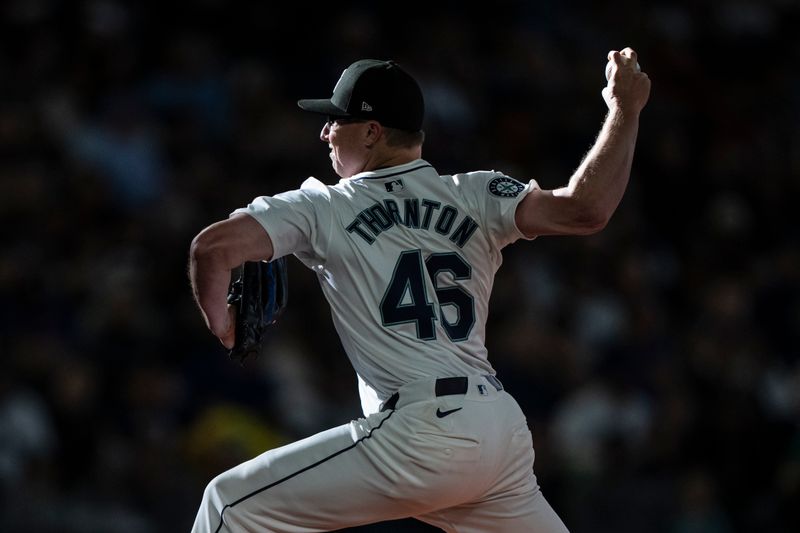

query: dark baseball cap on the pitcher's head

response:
[297,59,425,131]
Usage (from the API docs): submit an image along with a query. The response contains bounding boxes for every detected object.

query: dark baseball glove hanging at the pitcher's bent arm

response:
[228,257,289,364]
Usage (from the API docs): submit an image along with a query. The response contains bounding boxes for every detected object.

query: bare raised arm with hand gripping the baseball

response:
[515,48,650,237]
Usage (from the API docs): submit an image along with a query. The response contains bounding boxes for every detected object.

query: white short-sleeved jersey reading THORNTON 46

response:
[235,159,537,415]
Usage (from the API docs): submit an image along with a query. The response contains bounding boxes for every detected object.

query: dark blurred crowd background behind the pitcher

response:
[0,0,800,533]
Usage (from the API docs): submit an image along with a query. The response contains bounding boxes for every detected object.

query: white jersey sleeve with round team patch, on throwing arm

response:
[459,172,539,249]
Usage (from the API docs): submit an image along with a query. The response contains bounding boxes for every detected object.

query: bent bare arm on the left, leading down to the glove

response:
[189,214,273,348]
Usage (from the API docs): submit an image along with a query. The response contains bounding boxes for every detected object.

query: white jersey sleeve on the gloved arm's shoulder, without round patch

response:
[232,179,331,261]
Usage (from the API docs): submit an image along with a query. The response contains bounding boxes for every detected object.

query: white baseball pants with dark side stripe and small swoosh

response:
[192,376,567,533]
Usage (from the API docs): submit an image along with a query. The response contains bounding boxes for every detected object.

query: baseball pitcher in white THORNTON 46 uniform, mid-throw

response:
[189,48,650,533]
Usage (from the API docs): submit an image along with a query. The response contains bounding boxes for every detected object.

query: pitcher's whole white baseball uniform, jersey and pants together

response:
[192,160,567,533]
